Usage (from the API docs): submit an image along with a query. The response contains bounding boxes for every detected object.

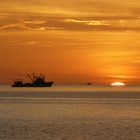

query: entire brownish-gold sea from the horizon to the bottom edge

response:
[0,85,140,140]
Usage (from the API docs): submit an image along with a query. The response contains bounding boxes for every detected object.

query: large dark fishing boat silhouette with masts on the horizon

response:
[12,73,54,87]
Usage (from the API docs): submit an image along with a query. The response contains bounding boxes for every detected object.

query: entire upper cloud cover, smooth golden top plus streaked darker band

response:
[0,0,140,32]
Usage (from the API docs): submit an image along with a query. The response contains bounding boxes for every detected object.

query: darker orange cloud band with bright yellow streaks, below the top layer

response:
[0,14,140,32]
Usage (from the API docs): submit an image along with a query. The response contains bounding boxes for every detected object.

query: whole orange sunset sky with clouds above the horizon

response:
[0,0,140,85]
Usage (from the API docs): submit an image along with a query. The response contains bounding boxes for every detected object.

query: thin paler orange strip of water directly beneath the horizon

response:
[0,85,140,93]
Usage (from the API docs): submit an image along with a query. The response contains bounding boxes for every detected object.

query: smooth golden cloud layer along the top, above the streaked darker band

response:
[0,0,140,17]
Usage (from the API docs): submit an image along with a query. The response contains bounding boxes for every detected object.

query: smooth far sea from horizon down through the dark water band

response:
[0,85,140,100]
